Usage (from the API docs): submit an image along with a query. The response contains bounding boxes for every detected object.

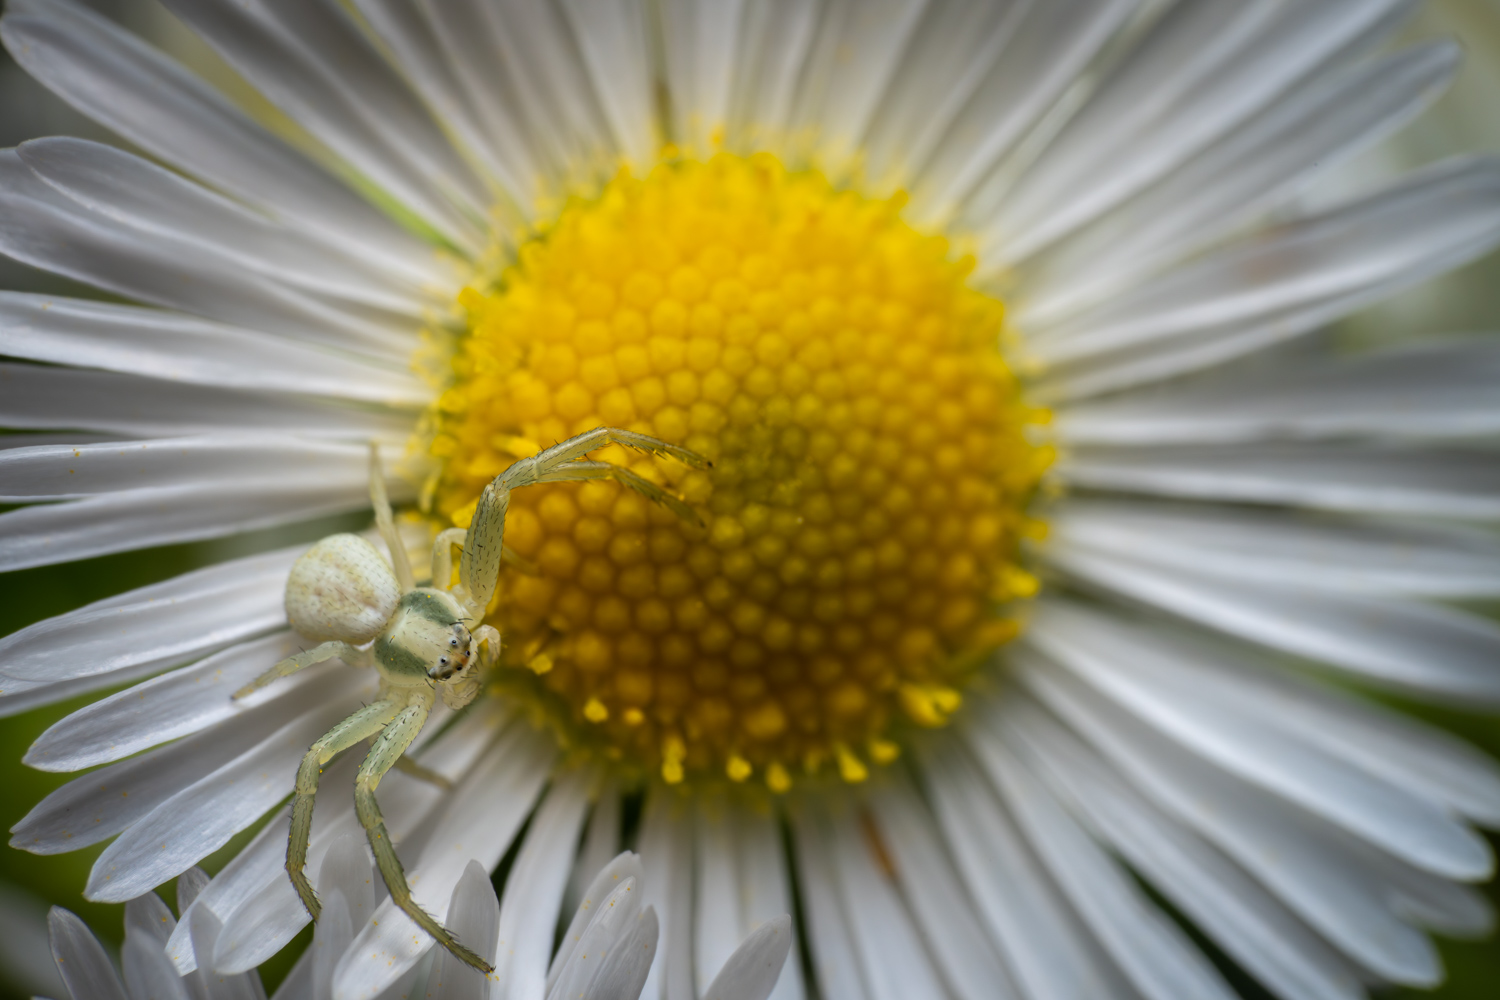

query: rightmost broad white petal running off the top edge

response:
[969,0,1413,267]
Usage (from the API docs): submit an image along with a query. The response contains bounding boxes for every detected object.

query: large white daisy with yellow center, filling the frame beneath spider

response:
[0,0,1500,1000]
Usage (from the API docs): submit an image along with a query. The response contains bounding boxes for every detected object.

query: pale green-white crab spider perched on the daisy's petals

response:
[234,427,708,973]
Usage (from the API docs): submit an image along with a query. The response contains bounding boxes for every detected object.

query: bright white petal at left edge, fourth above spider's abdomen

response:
[0,292,431,406]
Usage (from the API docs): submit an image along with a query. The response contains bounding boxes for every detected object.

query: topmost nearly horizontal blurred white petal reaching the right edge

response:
[1053,334,1500,444]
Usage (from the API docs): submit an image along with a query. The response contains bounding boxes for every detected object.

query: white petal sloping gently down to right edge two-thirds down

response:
[1049,547,1500,705]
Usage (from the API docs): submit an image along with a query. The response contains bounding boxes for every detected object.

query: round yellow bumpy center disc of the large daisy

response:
[432,154,1049,792]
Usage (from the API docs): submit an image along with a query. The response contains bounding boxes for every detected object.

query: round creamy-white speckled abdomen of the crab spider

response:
[287,535,401,646]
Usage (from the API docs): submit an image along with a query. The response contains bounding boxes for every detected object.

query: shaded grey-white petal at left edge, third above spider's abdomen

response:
[0,363,411,444]
